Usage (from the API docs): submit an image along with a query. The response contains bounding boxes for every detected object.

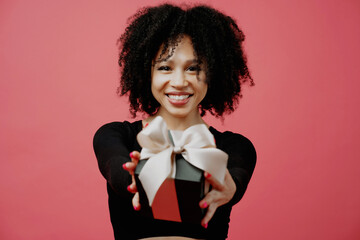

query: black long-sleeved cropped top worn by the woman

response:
[94,121,256,240]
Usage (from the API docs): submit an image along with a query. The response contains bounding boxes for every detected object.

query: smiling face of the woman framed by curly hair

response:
[151,35,208,118]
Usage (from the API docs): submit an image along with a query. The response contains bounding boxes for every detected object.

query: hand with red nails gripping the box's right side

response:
[199,169,236,228]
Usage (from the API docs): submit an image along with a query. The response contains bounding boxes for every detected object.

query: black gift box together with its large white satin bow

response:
[135,117,228,224]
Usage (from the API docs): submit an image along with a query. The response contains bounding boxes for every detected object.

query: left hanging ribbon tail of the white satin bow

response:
[139,148,172,206]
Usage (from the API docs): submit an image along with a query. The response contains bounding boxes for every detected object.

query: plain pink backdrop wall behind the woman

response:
[0,0,360,240]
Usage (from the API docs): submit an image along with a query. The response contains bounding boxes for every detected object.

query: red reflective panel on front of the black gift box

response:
[151,178,181,222]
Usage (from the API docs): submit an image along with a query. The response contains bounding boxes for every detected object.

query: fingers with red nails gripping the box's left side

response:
[123,151,141,211]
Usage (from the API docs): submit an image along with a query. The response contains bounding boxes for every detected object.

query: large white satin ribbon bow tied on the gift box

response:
[137,117,228,206]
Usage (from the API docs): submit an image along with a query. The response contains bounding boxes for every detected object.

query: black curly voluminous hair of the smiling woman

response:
[118,4,254,117]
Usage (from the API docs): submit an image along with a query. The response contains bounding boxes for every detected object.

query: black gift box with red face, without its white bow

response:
[135,154,207,224]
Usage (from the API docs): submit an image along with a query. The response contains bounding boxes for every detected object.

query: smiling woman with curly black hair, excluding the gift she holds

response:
[94,4,256,239]
